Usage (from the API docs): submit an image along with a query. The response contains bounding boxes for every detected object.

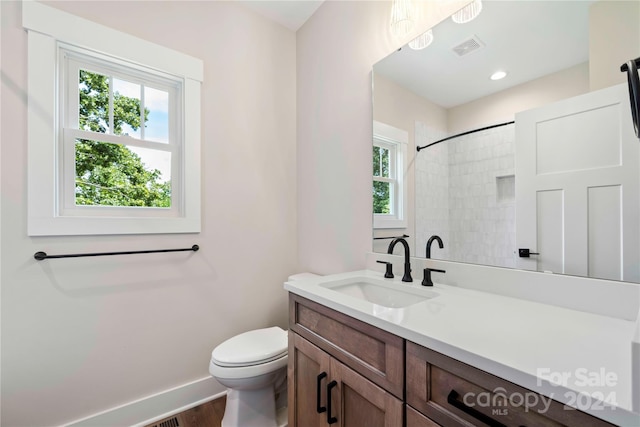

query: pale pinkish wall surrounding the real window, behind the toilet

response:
[0,1,296,427]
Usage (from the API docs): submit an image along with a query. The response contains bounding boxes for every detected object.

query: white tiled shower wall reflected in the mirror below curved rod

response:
[416,122,516,267]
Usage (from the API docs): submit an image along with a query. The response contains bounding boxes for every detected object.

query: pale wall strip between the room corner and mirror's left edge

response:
[297,1,468,274]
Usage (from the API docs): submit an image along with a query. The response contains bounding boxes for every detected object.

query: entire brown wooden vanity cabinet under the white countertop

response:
[288,294,612,427]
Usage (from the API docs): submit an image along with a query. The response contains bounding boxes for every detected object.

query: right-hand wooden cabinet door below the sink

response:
[330,359,402,427]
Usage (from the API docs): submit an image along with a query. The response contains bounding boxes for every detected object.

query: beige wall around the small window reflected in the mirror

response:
[373,74,447,253]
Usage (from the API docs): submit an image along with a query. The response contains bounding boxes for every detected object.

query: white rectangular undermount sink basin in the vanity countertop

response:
[320,277,438,308]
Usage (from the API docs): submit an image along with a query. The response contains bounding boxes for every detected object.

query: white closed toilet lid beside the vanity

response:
[211,326,287,366]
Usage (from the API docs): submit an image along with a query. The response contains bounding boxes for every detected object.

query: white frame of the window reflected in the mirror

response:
[372,120,409,229]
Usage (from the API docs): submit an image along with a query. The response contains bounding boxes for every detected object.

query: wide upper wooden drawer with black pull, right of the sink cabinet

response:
[407,342,612,427]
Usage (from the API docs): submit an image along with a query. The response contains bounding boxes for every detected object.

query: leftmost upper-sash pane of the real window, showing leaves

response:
[78,70,109,133]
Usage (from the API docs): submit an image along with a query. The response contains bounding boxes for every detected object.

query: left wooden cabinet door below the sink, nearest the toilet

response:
[287,331,330,427]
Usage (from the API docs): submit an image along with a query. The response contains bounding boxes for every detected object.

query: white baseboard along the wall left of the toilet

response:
[65,377,226,427]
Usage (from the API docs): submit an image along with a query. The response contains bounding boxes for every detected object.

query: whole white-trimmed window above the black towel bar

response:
[23,2,202,236]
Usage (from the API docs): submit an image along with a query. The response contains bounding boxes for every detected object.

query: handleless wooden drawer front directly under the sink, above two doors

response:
[289,294,404,398]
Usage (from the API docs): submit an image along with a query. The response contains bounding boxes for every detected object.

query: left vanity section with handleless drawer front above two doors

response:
[288,295,404,427]
